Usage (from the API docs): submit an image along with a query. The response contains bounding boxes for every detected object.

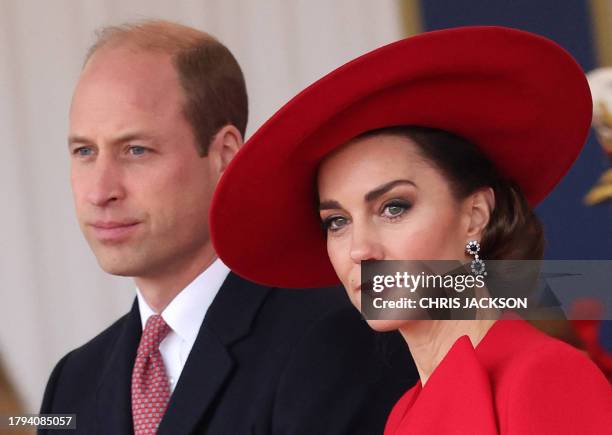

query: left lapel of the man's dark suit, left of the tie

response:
[96,301,142,435]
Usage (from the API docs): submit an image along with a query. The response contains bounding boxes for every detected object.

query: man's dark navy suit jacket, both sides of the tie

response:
[41,273,417,435]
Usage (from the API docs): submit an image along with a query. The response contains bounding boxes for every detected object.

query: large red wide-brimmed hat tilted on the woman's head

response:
[210,26,592,287]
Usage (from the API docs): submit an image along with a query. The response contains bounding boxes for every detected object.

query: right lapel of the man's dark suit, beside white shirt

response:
[158,273,269,435]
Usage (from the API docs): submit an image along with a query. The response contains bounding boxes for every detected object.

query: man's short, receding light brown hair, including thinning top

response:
[85,20,248,156]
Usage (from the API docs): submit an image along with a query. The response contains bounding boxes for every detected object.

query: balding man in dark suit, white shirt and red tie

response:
[41,22,416,435]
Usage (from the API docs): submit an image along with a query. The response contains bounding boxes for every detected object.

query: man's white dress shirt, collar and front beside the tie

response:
[136,259,229,393]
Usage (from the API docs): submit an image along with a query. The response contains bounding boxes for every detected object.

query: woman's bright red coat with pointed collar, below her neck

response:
[385,320,612,435]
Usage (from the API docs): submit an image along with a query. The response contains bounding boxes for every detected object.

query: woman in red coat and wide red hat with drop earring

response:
[211,27,612,435]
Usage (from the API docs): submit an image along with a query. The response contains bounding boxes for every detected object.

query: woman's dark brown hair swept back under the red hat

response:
[359,126,544,260]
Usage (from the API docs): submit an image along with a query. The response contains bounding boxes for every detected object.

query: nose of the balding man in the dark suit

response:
[87,155,125,207]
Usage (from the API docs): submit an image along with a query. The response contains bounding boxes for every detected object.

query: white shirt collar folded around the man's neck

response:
[136,258,230,344]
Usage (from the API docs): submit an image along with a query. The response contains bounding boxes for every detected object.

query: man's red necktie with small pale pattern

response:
[132,314,170,435]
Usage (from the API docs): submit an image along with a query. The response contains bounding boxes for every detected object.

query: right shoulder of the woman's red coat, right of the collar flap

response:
[496,326,612,435]
